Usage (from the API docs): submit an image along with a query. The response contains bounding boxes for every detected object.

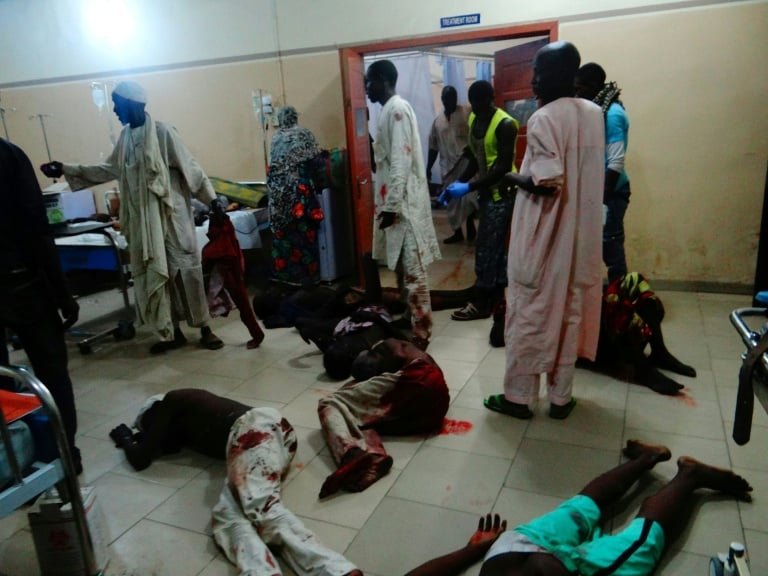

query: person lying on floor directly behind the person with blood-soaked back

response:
[296,305,406,380]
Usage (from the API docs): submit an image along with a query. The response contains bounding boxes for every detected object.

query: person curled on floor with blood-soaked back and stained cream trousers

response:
[317,338,450,498]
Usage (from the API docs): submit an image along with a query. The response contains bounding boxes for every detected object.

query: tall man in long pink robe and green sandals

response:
[484,42,605,419]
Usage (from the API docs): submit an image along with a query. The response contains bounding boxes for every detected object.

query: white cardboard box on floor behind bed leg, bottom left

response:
[27,486,109,576]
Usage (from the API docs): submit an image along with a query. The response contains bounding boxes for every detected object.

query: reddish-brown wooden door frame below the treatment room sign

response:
[339,20,558,281]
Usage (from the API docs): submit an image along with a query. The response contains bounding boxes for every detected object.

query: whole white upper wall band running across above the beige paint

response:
[0,0,744,87]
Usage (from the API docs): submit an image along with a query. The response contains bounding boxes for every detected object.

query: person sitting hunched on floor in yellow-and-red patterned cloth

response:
[579,272,696,395]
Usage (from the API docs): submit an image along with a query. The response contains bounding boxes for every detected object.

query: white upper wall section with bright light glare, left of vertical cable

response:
[0,0,278,87]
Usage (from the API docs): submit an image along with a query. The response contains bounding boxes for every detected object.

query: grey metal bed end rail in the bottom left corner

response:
[0,366,101,576]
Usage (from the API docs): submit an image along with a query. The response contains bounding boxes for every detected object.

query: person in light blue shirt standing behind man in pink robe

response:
[574,62,630,282]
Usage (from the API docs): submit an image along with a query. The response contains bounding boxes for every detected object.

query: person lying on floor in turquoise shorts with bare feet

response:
[406,440,752,576]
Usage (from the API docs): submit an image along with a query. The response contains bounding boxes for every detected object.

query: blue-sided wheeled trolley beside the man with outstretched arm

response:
[53,221,136,354]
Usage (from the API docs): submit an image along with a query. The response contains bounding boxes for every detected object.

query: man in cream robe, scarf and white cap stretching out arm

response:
[44,82,224,353]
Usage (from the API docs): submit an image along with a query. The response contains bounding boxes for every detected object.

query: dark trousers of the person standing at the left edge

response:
[0,273,80,462]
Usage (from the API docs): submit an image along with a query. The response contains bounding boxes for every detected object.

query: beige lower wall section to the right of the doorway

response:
[560,4,768,285]
